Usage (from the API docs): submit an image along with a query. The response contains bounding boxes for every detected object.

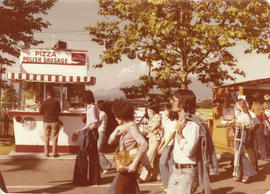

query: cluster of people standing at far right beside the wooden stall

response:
[233,92,270,183]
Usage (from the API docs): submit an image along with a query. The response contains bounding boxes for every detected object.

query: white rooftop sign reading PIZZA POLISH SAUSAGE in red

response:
[20,49,89,76]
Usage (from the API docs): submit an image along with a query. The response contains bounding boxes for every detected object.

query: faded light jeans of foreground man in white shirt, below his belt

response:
[167,167,198,194]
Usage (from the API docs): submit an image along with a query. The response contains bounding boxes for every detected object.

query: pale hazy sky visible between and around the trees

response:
[5,0,270,95]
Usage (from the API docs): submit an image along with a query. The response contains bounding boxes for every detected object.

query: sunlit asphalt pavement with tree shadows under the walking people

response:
[0,153,270,194]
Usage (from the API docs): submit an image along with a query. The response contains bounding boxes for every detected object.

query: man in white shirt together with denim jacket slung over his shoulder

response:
[168,89,218,194]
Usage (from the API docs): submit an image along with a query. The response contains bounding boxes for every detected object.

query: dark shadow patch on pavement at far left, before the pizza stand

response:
[1,155,42,172]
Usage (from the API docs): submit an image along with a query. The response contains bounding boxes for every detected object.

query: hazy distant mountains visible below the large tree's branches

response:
[94,78,212,100]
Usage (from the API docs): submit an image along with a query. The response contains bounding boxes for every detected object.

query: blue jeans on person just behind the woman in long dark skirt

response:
[97,131,112,170]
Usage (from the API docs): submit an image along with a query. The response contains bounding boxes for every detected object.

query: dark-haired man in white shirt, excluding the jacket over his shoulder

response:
[168,89,200,194]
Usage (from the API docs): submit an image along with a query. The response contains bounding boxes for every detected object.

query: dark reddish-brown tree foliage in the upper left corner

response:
[0,0,56,94]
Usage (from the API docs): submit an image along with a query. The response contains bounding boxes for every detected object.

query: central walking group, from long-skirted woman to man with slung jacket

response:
[66,89,218,194]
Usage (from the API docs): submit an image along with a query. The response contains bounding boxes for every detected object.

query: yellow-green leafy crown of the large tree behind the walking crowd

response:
[86,0,270,102]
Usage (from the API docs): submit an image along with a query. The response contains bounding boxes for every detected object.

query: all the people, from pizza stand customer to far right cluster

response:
[35,89,270,194]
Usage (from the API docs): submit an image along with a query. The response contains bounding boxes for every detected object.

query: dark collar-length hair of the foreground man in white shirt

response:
[173,89,196,114]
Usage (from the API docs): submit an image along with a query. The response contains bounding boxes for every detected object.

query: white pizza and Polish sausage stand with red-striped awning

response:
[6,49,96,153]
